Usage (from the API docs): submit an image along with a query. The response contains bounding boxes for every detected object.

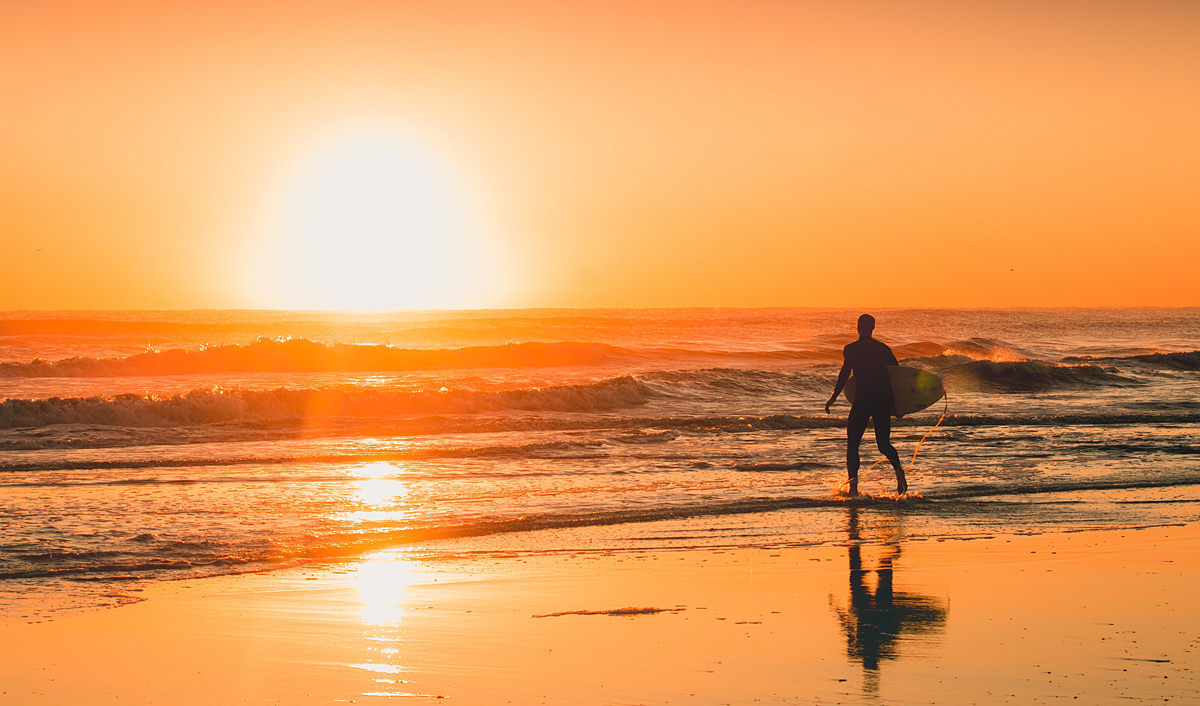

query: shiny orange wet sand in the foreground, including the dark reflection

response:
[0,510,1200,704]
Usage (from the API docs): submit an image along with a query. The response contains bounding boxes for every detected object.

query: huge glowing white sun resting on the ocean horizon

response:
[247,131,503,310]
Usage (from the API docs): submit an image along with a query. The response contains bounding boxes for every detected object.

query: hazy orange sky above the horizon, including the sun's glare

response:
[0,0,1200,309]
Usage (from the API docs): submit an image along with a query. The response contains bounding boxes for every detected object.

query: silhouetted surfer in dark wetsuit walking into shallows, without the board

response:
[826,313,908,495]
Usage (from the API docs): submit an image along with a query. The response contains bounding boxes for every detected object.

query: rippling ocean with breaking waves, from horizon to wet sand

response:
[0,309,1200,615]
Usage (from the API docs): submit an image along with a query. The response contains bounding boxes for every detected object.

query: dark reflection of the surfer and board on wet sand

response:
[829,508,948,693]
